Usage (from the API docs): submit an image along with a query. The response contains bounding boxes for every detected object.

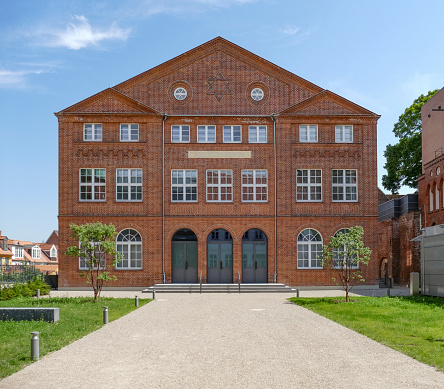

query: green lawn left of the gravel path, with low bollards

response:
[0,297,151,379]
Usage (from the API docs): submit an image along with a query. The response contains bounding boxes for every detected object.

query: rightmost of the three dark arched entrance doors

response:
[242,228,268,283]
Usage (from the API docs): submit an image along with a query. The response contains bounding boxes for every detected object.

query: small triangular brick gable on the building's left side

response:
[56,88,158,115]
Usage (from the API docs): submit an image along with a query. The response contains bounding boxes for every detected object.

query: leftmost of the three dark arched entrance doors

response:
[171,228,197,284]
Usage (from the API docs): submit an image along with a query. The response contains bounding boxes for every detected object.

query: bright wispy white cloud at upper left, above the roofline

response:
[38,15,131,50]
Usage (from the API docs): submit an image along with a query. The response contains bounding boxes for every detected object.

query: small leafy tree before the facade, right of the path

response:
[321,226,372,302]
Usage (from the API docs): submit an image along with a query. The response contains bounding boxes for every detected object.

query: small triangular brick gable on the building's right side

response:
[279,90,378,117]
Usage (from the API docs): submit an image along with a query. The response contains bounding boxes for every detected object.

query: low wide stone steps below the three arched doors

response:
[142,284,296,293]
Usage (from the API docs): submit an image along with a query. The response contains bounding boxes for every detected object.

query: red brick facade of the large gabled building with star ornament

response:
[56,38,379,287]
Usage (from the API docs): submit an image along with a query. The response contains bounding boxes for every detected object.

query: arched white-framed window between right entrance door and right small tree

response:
[297,228,322,269]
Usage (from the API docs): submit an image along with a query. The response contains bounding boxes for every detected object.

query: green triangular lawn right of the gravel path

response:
[289,296,444,371]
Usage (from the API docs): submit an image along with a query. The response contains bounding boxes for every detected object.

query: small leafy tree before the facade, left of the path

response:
[65,223,123,302]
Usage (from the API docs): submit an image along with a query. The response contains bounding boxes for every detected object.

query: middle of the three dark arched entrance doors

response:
[207,228,233,284]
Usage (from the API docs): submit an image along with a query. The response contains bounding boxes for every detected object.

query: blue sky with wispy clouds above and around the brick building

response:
[0,0,444,242]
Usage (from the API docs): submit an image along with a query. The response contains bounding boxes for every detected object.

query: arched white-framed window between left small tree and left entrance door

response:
[116,228,142,269]
